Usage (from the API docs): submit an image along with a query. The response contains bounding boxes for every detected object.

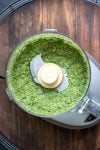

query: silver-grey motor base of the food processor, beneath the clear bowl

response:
[45,53,100,129]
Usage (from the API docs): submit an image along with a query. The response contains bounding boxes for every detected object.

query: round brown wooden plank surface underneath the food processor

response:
[0,0,100,150]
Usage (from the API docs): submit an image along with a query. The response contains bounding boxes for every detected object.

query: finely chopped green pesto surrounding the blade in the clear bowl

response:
[7,33,90,116]
